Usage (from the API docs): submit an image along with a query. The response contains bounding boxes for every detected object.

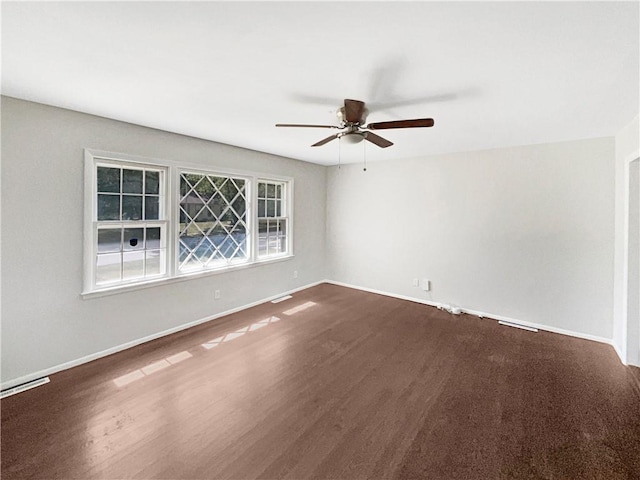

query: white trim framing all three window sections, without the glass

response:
[81,148,294,298]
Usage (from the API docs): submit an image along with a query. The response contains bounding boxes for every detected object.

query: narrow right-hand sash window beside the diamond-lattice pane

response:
[258,180,288,258]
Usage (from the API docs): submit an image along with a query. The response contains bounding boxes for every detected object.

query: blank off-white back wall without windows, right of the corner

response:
[327,138,615,339]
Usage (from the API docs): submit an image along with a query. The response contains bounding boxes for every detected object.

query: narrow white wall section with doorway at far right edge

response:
[613,116,640,365]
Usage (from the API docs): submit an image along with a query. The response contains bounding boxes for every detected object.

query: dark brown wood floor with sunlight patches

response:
[1,285,640,479]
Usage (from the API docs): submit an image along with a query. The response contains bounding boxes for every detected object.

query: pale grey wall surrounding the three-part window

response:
[2,97,326,388]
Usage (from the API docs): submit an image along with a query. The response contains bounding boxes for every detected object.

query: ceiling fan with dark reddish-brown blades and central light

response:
[276,99,434,148]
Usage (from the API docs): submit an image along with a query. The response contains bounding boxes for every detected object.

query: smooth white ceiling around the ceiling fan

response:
[2,2,640,165]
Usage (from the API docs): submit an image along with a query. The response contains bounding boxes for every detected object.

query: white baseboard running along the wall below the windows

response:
[0,280,325,390]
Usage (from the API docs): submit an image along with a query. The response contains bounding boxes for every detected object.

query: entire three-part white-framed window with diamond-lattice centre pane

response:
[84,150,293,293]
